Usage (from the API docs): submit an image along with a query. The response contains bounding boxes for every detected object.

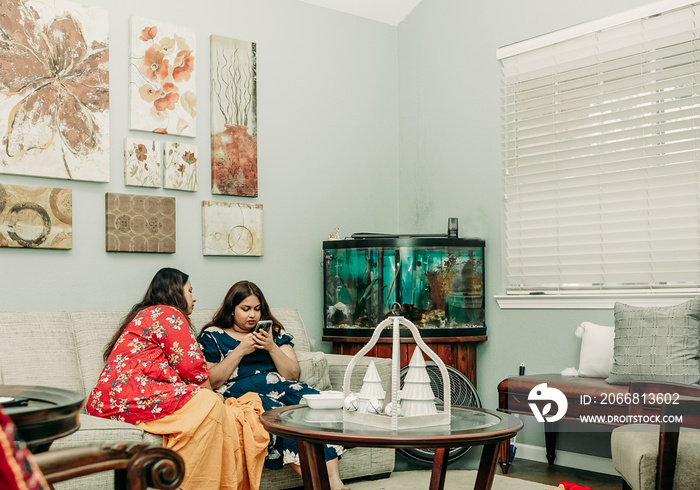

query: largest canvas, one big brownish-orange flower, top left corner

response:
[0,0,109,182]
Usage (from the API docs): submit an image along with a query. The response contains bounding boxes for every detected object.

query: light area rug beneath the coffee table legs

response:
[347,469,557,490]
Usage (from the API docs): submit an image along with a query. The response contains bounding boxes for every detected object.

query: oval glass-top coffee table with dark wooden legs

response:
[260,405,523,490]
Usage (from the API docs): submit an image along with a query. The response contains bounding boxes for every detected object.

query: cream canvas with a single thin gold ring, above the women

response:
[202,201,263,256]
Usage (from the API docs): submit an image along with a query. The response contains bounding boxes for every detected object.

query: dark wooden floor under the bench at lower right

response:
[504,459,622,490]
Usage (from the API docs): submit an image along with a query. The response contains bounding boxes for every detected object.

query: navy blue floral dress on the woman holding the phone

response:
[197,327,345,469]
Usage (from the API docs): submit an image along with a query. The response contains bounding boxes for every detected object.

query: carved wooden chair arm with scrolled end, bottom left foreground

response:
[34,442,185,490]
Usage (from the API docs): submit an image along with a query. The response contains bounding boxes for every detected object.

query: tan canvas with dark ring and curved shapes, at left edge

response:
[0,184,73,250]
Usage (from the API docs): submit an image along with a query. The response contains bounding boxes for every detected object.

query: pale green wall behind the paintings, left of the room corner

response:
[0,0,398,347]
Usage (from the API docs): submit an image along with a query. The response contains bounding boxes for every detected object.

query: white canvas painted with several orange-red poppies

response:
[129,17,197,137]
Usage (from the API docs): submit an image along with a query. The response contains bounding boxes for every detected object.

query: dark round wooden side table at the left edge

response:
[0,385,85,453]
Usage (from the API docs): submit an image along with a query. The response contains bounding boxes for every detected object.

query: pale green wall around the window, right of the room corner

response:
[398,0,648,454]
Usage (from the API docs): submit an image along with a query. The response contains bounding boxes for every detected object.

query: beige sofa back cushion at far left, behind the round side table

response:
[0,311,85,393]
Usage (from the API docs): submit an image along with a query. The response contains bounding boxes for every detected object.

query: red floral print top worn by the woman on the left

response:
[86,305,209,424]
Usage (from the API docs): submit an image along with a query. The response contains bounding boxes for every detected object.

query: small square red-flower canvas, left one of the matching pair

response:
[124,138,163,187]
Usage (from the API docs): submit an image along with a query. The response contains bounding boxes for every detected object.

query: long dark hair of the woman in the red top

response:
[103,267,190,362]
